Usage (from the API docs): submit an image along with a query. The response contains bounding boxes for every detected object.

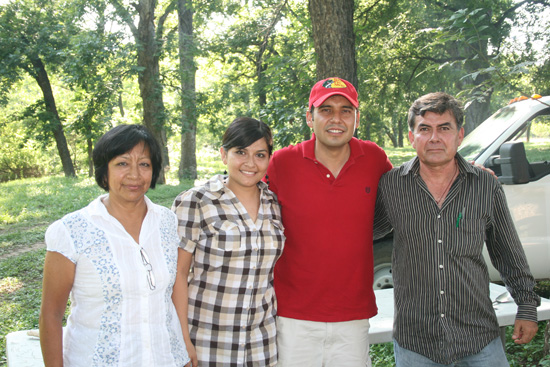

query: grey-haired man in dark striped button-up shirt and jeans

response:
[374,93,540,367]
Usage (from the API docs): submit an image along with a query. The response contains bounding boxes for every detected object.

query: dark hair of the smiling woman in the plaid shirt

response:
[222,117,273,155]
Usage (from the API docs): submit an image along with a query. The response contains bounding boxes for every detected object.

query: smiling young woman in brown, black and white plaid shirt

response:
[172,117,284,367]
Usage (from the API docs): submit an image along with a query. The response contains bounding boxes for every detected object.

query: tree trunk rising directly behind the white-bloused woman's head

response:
[136,0,170,183]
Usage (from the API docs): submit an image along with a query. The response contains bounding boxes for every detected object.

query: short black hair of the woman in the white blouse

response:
[92,125,162,192]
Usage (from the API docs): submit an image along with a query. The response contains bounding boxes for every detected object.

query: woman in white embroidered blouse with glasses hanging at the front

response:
[40,125,190,367]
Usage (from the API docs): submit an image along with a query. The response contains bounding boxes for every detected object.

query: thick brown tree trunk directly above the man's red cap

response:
[309,0,359,89]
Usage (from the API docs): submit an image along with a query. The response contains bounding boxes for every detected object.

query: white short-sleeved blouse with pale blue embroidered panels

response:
[46,194,189,367]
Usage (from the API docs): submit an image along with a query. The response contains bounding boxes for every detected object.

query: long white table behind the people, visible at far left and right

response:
[6,283,550,367]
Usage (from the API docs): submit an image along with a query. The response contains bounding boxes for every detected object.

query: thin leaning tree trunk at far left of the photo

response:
[31,57,76,177]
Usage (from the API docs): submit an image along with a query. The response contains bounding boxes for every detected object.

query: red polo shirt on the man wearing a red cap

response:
[268,136,392,322]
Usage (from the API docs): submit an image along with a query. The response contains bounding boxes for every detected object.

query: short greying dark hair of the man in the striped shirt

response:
[407,92,464,131]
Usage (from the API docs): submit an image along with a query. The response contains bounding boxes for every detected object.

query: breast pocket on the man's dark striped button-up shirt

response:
[450,218,486,257]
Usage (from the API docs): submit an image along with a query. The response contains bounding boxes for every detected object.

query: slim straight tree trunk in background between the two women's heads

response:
[178,0,197,180]
